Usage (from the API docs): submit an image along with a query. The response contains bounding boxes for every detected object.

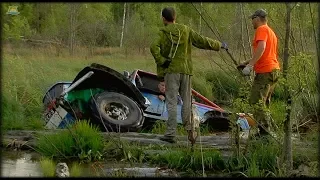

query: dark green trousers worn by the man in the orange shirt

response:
[249,69,280,132]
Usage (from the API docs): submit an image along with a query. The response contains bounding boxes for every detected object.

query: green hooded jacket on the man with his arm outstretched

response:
[150,23,221,77]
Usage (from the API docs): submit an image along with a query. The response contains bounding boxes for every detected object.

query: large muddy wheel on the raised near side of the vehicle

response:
[90,91,144,132]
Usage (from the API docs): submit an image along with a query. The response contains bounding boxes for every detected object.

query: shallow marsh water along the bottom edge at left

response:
[1,150,180,177]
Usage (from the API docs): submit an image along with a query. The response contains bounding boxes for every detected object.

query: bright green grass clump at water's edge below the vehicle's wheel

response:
[36,120,104,162]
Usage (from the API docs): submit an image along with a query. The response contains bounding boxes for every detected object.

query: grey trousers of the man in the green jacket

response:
[164,73,192,137]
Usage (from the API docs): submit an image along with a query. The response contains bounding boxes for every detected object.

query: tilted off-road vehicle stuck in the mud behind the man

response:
[43,63,229,131]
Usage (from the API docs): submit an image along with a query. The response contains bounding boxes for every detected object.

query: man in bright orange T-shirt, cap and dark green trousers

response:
[241,9,280,135]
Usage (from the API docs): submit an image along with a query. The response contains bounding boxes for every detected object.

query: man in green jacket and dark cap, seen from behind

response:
[150,7,227,143]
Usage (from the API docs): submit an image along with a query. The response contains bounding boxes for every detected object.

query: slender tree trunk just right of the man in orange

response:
[282,3,293,174]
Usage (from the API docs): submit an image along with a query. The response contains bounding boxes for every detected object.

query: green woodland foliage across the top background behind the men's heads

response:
[2,3,316,52]
